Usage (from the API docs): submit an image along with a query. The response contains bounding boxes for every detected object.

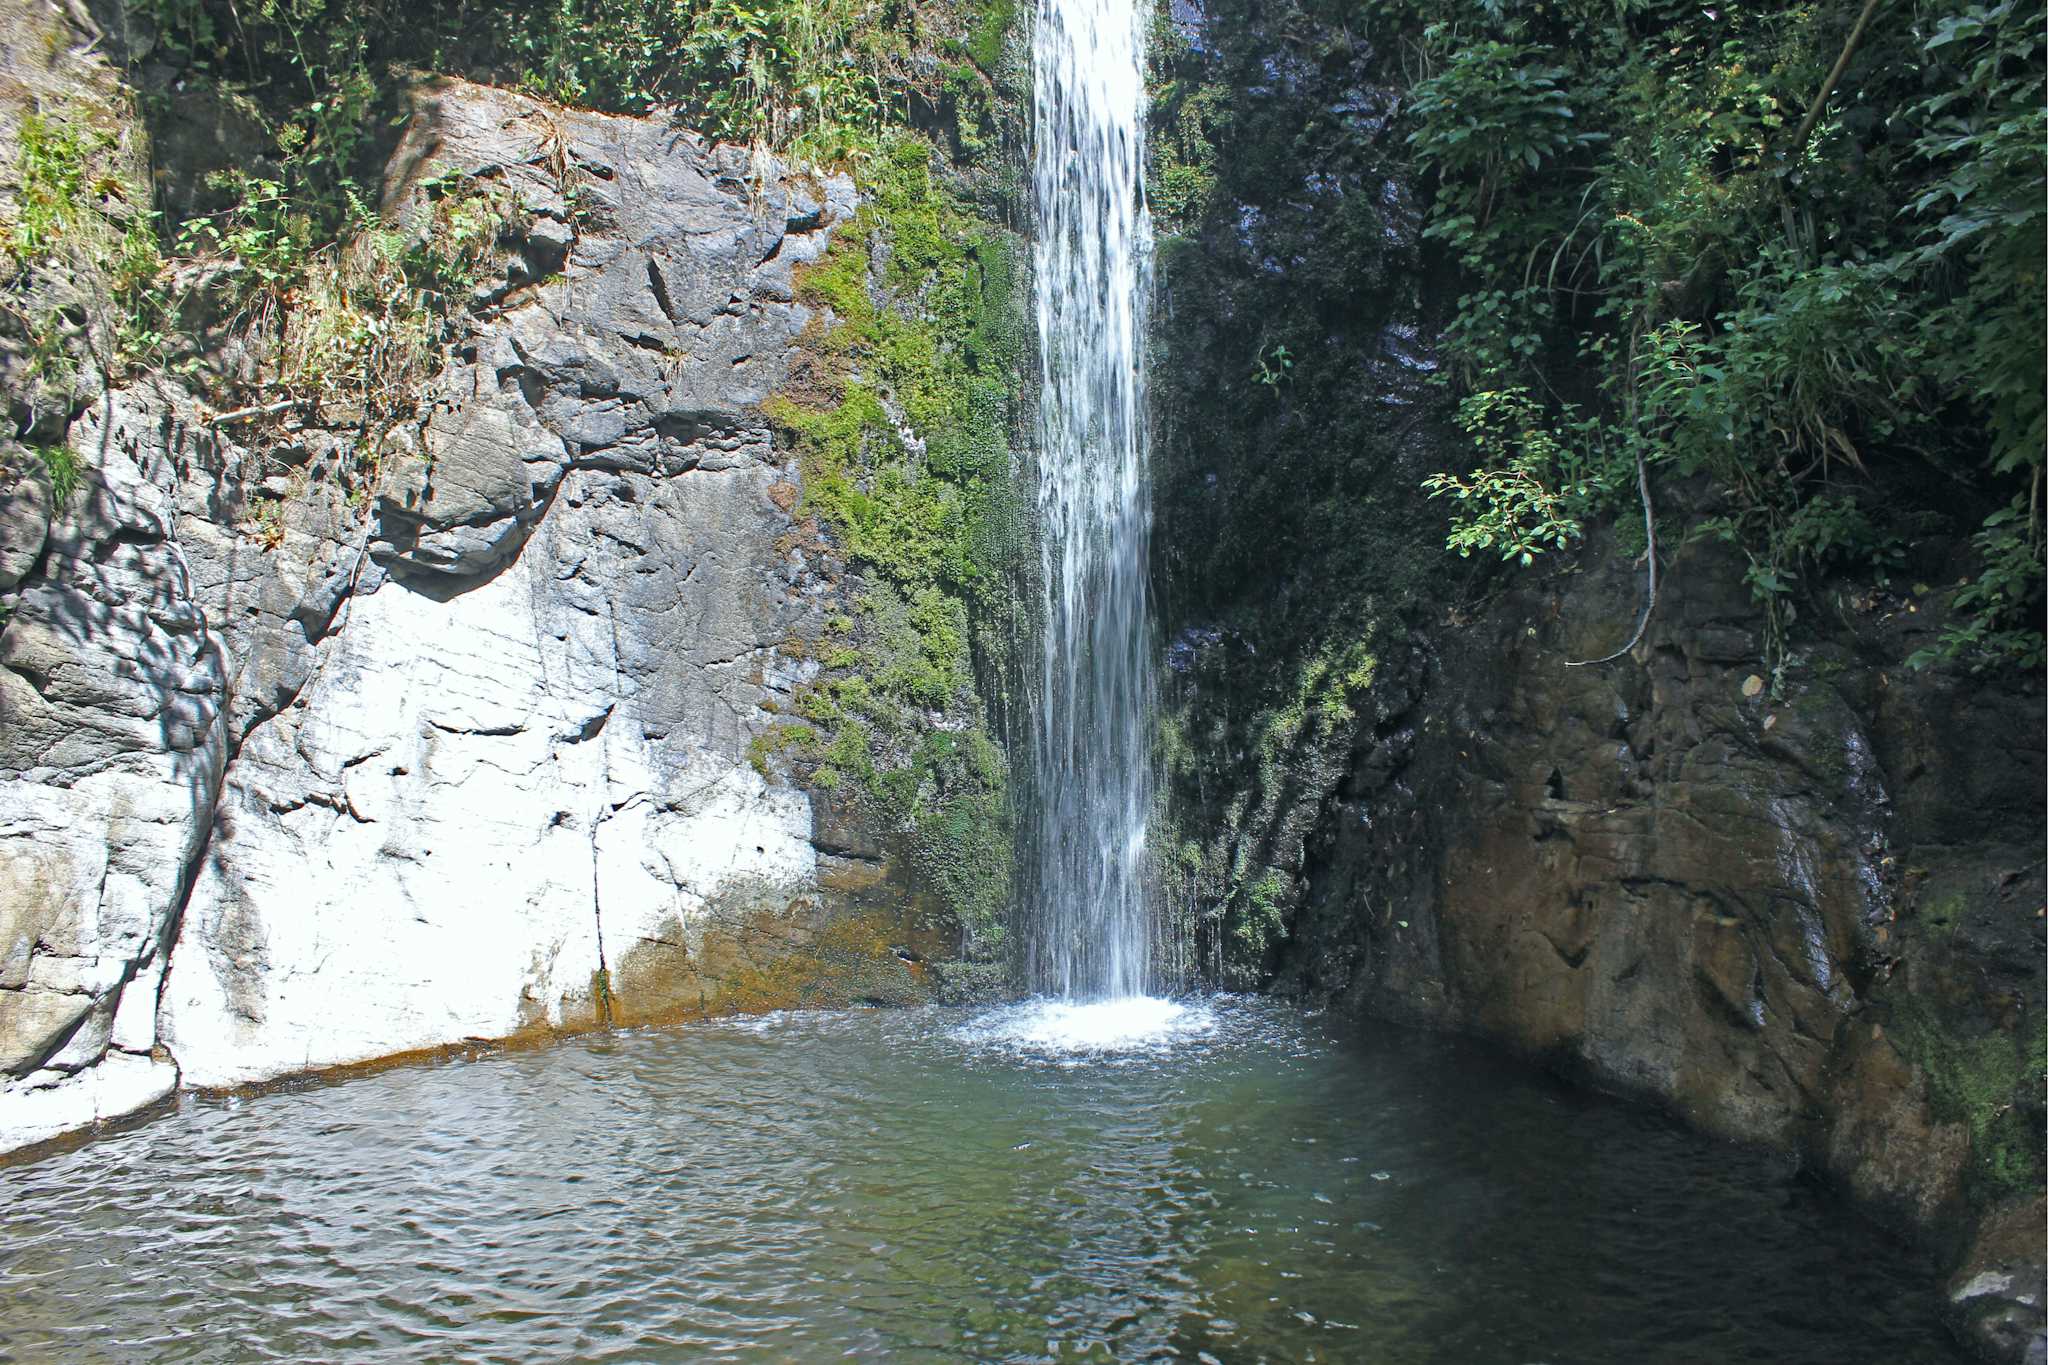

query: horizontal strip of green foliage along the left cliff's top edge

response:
[129,0,1014,163]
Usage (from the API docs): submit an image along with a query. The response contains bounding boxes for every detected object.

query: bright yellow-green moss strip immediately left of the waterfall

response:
[754,4,1030,962]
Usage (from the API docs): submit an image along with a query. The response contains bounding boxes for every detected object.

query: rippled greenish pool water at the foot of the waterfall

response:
[0,1001,1958,1365]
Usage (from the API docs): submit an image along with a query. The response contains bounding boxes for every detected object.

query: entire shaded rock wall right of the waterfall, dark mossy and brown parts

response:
[1155,2,2048,1359]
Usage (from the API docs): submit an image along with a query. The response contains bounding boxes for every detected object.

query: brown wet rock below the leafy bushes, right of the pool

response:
[1276,532,2044,1359]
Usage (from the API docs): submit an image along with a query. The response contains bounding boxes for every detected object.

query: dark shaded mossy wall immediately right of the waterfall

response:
[1149,0,1460,986]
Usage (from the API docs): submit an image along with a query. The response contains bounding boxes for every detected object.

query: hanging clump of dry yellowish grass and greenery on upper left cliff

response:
[99,0,495,470]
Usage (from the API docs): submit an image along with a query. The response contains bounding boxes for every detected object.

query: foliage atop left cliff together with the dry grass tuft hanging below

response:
[116,0,989,446]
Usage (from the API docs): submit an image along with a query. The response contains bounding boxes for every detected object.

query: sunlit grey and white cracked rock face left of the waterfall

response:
[0,66,948,1148]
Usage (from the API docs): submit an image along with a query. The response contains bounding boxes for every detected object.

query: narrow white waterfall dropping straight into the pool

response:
[1028,0,1155,999]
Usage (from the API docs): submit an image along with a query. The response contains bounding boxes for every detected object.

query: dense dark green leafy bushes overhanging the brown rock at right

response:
[1378,0,2048,667]
